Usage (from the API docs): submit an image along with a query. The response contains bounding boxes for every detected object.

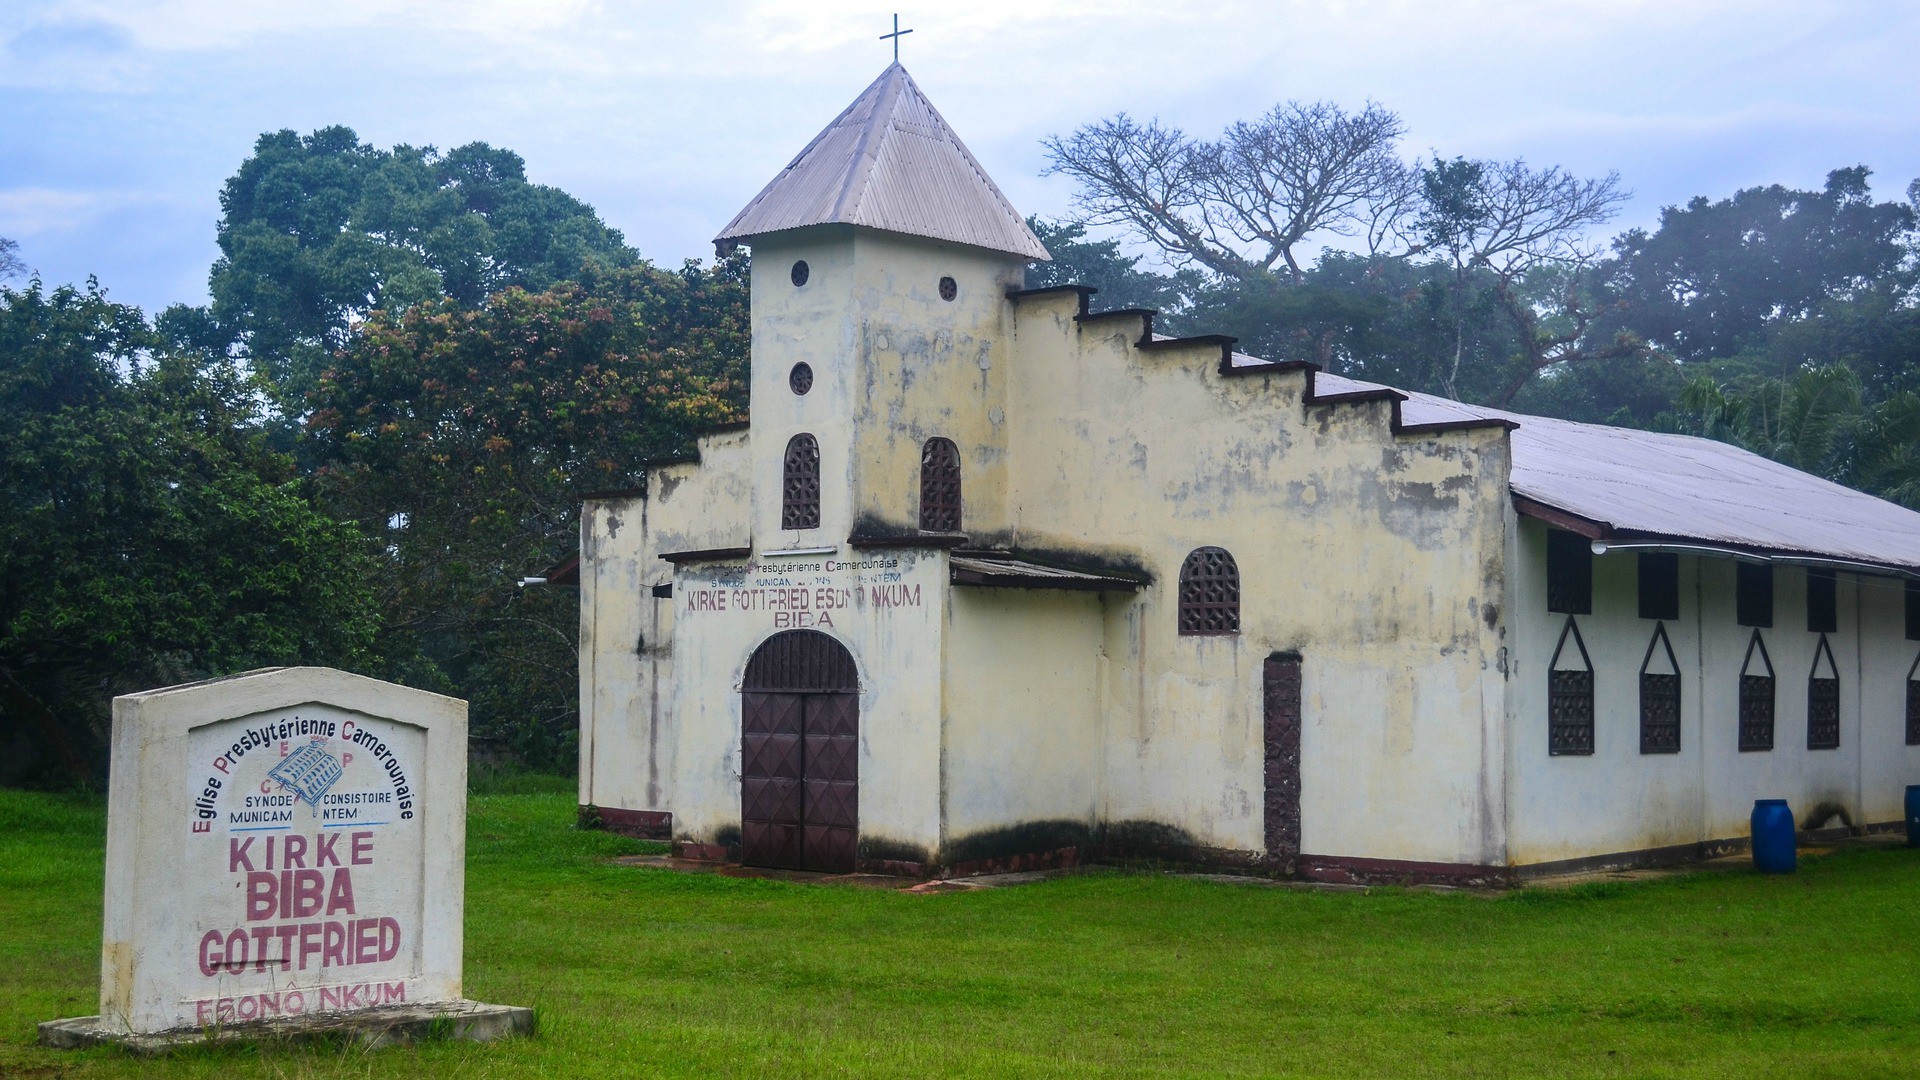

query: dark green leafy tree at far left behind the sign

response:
[0,282,378,782]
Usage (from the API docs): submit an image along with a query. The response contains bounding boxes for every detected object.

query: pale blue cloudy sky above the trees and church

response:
[0,0,1920,311]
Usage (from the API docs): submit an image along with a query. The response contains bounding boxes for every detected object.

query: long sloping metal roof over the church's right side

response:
[1313,373,1920,571]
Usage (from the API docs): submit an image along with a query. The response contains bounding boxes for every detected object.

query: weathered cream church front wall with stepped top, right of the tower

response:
[1010,294,1511,865]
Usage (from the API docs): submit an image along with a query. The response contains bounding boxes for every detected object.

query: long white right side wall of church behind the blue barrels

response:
[1507,519,1920,865]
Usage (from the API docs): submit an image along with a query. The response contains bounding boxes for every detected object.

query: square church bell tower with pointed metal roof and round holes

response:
[714,61,1048,552]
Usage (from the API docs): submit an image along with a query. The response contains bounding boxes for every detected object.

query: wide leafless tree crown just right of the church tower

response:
[1046,102,1419,281]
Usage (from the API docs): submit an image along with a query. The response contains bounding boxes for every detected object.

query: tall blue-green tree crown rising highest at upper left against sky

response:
[209,127,636,401]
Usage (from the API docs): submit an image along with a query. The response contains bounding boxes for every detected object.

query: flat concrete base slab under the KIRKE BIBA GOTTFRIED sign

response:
[40,1001,534,1055]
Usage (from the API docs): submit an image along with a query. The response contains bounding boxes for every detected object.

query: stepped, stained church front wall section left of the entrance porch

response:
[580,430,751,813]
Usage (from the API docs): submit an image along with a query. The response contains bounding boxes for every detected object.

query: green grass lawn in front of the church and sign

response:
[0,784,1920,1080]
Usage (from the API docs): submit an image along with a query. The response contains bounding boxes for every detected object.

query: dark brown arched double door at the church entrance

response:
[739,630,860,872]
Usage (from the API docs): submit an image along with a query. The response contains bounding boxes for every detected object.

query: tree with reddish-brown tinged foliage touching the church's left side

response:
[307,258,749,765]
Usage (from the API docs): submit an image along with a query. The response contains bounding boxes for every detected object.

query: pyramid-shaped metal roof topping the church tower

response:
[714,61,1048,259]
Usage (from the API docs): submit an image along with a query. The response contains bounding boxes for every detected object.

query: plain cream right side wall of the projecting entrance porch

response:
[941,588,1105,863]
